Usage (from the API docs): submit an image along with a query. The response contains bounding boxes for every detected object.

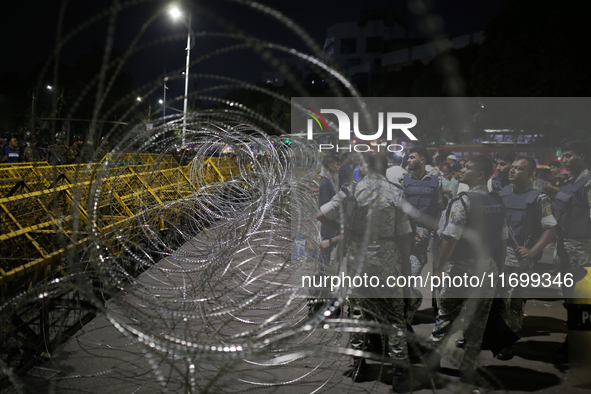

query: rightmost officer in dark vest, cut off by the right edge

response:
[552,141,591,362]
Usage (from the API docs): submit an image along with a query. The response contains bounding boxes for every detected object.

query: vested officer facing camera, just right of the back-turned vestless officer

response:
[399,146,443,275]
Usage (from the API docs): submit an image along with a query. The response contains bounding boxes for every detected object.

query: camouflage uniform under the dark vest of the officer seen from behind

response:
[429,185,508,371]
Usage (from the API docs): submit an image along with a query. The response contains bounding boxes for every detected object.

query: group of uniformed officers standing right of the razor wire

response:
[311,141,591,392]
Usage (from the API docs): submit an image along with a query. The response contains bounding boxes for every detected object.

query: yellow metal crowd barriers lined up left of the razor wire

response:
[0,153,239,376]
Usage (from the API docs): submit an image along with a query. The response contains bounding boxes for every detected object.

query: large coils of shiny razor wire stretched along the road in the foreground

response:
[0,1,512,393]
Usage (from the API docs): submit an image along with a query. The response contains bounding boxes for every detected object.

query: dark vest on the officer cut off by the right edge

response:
[552,174,591,239]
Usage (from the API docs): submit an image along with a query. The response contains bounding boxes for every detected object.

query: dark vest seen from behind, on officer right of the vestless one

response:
[447,192,505,260]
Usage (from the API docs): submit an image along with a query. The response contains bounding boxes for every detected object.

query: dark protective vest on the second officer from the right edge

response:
[500,185,542,248]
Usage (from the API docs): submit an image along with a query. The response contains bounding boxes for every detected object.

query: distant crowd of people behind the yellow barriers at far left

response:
[0,131,112,165]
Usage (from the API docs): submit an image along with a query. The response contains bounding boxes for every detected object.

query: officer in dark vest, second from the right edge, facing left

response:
[496,157,557,360]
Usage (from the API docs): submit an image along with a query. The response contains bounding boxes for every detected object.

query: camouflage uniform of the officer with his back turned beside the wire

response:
[320,173,420,361]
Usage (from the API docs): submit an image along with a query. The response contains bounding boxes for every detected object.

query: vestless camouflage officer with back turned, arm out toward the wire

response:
[317,154,420,391]
